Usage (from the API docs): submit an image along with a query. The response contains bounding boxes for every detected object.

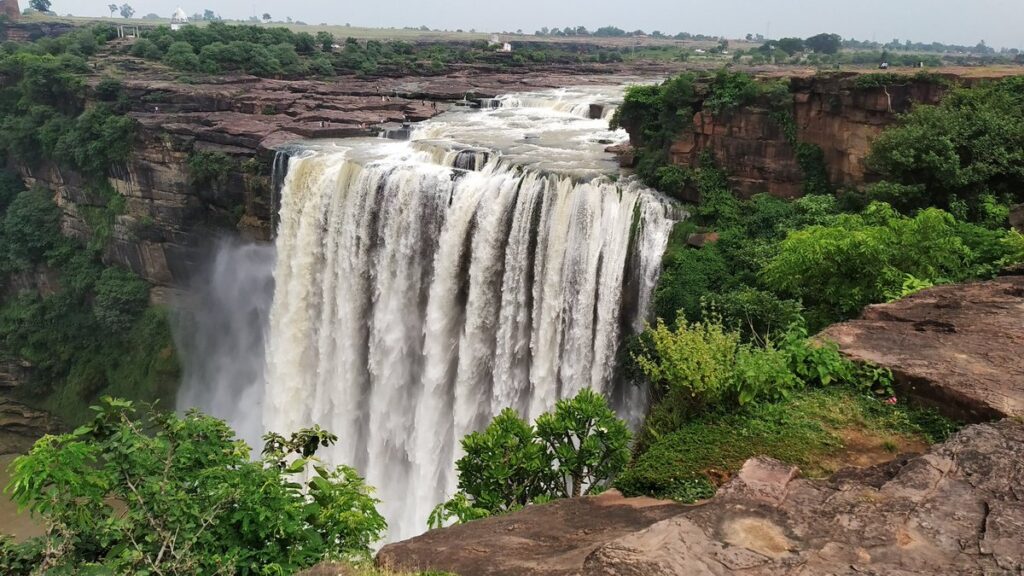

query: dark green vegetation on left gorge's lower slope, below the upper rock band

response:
[0,173,178,424]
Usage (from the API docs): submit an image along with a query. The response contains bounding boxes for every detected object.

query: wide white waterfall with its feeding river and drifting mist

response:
[179,87,678,540]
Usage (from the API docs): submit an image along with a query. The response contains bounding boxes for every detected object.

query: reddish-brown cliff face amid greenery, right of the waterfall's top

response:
[627,74,946,198]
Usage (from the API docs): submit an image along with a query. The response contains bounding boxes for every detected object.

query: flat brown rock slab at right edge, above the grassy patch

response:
[820,276,1024,421]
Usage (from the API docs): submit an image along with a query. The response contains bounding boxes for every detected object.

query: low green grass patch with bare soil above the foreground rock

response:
[615,387,957,502]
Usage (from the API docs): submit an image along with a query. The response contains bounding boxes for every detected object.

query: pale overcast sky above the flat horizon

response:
[49,0,1024,48]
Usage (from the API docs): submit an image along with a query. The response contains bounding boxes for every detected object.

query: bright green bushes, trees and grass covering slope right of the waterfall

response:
[613,72,1024,500]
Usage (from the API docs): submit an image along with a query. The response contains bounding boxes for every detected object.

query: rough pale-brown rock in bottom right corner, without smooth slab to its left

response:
[580,420,1024,576]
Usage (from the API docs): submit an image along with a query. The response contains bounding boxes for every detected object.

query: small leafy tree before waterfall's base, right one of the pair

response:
[537,388,630,497]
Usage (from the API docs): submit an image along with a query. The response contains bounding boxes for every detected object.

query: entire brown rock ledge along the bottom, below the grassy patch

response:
[378,420,1024,576]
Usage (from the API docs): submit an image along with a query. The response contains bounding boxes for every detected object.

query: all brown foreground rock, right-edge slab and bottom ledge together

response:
[377,276,1024,576]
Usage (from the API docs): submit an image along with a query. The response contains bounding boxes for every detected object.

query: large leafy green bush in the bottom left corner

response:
[0,398,386,576]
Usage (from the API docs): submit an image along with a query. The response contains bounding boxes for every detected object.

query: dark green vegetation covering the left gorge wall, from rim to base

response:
[0,27,178,424]
